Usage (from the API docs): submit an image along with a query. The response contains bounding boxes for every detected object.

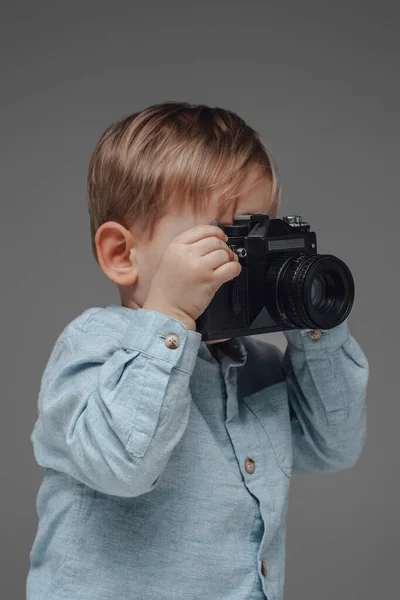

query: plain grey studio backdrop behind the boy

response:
[0,0,400,600]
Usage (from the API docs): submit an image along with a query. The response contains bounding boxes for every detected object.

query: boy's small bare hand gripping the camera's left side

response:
[143,225,242,331]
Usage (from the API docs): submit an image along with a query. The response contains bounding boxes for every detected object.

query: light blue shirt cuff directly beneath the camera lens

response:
[283,319,349,350]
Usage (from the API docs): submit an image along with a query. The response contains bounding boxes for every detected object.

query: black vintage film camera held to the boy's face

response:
[196,213,354,341]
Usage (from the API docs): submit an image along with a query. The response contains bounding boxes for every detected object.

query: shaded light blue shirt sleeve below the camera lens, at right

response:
[279,320,369,472]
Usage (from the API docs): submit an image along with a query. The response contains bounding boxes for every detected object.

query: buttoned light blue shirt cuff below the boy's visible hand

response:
[121,308,202,373]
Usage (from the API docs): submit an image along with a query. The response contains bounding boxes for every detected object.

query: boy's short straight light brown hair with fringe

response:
[87,102,280,260]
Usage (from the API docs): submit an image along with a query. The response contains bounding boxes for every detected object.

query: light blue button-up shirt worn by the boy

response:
[27,305,368,600]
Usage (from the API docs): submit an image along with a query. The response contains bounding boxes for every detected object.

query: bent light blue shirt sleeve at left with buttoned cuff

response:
[32,309,201,497]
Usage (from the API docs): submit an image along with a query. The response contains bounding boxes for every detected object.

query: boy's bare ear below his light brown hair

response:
[95,221,138,286]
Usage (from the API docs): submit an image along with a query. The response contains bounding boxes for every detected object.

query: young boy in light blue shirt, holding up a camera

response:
[27,102,368,600]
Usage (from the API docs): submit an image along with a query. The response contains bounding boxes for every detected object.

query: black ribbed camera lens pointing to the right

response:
[265,254,354,329]
